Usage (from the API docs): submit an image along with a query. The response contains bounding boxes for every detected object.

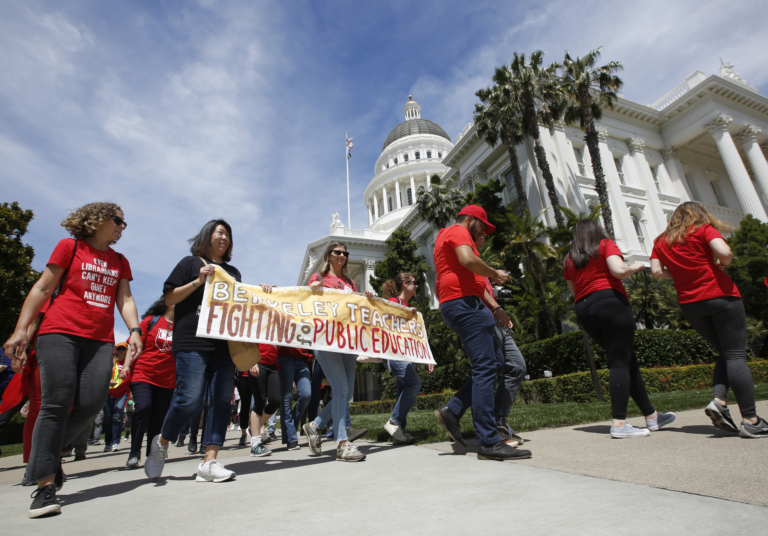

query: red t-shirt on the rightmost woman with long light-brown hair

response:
[651,225,741,303]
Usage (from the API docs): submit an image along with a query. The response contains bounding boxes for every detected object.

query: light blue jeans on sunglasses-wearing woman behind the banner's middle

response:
[315,350,356,442]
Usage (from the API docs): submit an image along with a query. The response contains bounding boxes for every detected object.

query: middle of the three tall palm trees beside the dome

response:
[493,50,565,227]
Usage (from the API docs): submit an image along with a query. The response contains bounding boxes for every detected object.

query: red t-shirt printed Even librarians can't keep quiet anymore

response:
[38,238,133,342]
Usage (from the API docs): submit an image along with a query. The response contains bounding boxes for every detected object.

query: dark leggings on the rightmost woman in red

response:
[680,296,757,419]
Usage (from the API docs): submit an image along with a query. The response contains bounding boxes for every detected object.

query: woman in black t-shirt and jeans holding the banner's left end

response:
[144,220,240,482]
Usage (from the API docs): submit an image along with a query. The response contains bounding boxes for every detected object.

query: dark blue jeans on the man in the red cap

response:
[440,296,504,446]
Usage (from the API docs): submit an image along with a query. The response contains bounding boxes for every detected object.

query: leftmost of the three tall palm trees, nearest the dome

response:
[475,84,528,211]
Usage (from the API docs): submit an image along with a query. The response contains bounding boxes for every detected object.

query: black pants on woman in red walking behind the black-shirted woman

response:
[129,382,173,457]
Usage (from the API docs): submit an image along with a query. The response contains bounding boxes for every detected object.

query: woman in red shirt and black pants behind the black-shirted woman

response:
[125,296,176,469]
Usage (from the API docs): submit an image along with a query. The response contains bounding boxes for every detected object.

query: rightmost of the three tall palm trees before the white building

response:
[560,47,624,236]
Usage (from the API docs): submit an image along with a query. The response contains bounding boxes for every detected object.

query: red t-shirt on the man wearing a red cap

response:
[434,225,485,304]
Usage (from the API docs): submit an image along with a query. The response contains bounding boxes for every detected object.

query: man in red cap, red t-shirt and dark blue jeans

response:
[434,205,531,460]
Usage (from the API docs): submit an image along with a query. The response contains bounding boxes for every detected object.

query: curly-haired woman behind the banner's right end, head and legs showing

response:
[381,272,432,445]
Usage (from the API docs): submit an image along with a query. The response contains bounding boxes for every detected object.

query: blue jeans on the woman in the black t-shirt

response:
[160,351,235,447]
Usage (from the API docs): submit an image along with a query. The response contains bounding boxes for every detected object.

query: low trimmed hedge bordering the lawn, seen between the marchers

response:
[362,360,768,415]
